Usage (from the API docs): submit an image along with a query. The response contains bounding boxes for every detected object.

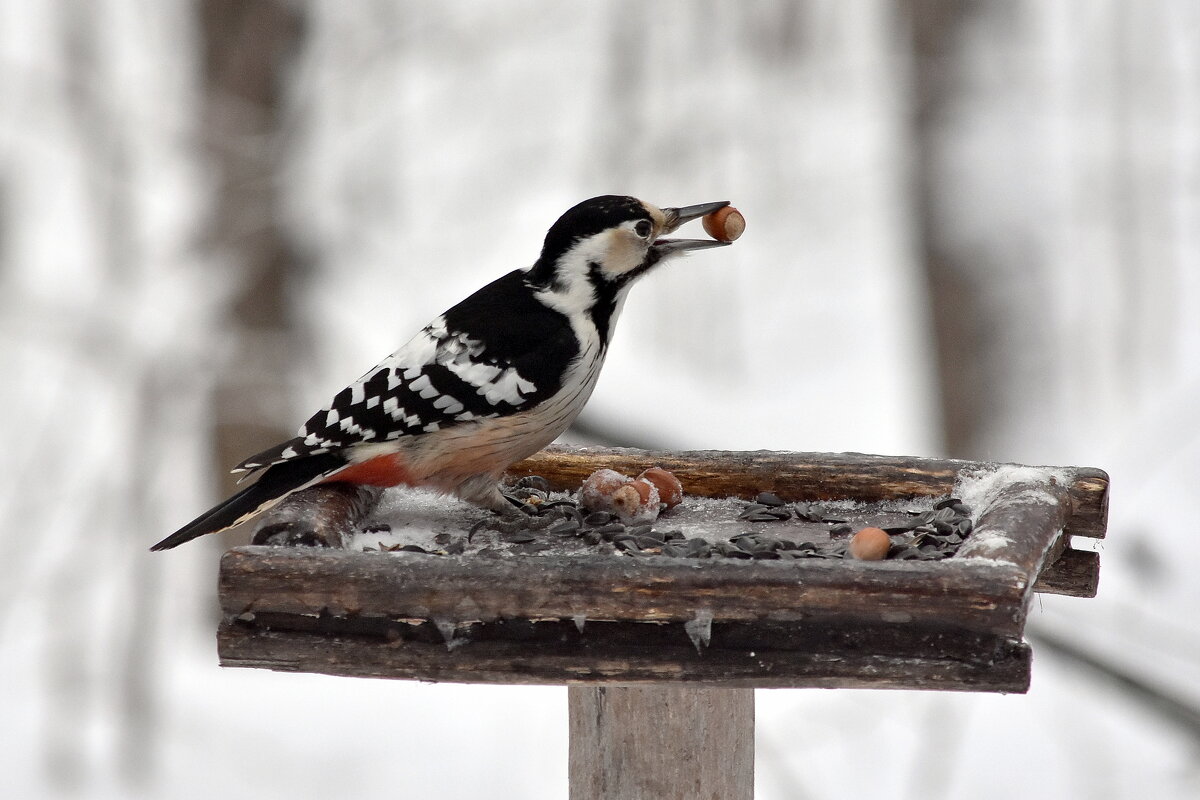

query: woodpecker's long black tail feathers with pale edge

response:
[150,453,347,551]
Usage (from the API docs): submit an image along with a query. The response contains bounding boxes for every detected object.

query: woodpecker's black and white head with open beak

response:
[529,194,728,342]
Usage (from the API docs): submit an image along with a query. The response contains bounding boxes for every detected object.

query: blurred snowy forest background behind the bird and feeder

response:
[0,0,1200,800]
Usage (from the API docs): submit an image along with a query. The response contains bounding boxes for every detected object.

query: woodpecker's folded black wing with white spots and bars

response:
[233,271,574,473]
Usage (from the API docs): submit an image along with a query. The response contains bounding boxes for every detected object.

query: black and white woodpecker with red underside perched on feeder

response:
[151,196,728,551]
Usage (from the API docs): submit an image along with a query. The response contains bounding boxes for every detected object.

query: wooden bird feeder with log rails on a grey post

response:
[217,447,1109,798]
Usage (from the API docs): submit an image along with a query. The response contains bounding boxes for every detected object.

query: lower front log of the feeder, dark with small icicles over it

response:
[217,618,1030,692]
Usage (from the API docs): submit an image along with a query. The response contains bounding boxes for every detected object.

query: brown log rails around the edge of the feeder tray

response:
[218,447,1108,692]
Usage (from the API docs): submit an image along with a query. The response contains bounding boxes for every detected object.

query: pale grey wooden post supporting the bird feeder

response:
[568,685,754,800]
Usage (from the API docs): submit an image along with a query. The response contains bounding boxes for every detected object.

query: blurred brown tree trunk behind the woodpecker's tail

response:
[196,0,306,544]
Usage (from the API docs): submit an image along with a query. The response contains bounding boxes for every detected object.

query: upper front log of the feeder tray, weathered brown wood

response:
[220,546,1031,636]
